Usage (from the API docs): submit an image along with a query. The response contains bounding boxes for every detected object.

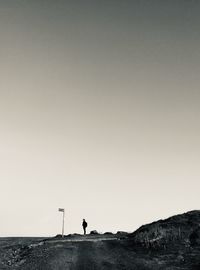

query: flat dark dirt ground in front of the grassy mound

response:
[0,235,200,270]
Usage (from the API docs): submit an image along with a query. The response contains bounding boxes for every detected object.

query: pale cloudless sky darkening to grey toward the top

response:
[0,0,200,236]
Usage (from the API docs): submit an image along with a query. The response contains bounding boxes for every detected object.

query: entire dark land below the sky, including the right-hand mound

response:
[0,211,200,270]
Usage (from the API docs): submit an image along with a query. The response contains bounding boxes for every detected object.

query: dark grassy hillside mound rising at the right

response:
[130,210,200,248]
